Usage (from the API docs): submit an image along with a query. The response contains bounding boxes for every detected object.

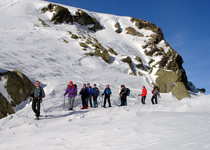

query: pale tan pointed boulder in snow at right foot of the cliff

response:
[172,82,191,100]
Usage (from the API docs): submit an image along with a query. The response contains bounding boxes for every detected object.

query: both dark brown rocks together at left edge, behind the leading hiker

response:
[0,70,34,118]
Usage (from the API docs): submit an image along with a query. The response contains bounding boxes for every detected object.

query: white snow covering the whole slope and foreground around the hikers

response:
[0,0,210,150]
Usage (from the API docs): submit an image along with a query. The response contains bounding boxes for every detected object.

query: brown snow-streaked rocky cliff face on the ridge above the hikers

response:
[41,4,190,100]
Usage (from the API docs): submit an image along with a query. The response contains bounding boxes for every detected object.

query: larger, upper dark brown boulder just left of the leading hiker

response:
[5,70,34,106]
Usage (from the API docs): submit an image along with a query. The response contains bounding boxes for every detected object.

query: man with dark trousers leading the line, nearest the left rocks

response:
[30,81,45,119]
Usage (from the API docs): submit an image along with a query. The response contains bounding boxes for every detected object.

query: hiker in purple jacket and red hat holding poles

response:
[64,81,77,110]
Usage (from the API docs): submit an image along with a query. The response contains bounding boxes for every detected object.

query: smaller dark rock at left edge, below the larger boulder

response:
[0,93,15,119]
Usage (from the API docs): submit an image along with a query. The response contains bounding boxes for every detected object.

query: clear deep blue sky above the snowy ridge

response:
[48,0,210,94]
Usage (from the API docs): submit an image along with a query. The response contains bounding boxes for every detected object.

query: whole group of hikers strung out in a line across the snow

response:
[30,81,160,118]
